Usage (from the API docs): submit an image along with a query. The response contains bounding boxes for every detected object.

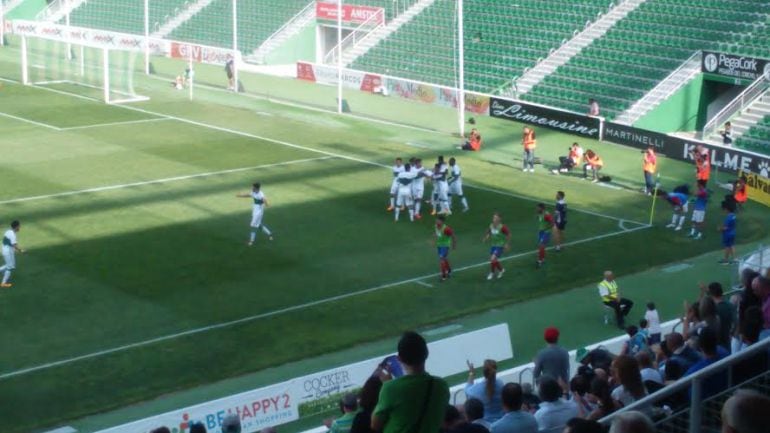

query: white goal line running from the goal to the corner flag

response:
[0,78,646,226]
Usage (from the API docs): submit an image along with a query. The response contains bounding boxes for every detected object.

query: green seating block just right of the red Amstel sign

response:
[352,0,609,92]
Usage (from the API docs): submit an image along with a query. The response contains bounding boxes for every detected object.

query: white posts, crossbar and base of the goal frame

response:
[21,35,150,104]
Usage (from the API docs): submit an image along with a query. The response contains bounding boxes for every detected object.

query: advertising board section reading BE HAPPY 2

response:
[98,382,299,433]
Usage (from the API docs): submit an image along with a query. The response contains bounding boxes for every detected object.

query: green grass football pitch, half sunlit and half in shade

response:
[0,41,767,432]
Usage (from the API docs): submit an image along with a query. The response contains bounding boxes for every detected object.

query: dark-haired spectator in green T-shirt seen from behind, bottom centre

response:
[372,331,449,433]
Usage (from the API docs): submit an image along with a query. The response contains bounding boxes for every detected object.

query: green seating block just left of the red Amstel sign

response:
[169,0,309,54]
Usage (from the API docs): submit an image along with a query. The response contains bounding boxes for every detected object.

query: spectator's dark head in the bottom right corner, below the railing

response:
[722,389,770,433]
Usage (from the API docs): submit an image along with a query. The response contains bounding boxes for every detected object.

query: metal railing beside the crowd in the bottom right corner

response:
[600,339,770,433]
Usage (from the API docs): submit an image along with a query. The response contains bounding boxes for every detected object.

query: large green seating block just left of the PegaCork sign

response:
[524,0,770,119]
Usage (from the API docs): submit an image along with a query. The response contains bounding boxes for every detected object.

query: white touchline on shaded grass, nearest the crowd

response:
[0,226,649,380]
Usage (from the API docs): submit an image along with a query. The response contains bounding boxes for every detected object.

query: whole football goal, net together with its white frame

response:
[21,36,149,104]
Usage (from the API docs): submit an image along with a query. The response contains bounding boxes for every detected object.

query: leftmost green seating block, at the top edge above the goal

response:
[70,0,191,34]
